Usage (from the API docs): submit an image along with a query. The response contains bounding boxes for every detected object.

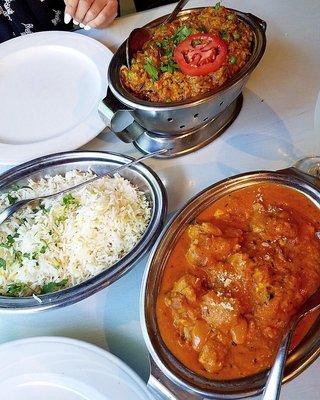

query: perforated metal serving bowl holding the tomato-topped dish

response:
[101,8,266,135]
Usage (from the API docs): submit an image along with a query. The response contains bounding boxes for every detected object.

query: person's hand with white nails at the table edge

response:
[64,0,118,30]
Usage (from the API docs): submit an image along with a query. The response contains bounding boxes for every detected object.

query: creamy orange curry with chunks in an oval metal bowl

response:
[157,183,320,379]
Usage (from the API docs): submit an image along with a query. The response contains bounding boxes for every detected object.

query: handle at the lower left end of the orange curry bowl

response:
[147,357,205,400]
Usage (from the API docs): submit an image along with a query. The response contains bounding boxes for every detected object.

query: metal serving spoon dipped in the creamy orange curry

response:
[261,284,320,400]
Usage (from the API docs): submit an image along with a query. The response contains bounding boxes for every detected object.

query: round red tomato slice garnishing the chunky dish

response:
[173,33,228,76]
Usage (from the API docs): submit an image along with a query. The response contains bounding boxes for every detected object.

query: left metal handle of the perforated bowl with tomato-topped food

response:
[98,88,144,143]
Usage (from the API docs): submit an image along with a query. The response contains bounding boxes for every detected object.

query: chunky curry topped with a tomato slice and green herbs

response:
[120,3,252,102]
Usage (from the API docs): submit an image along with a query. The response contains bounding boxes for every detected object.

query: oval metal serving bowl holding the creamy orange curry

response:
[141,158,320,400]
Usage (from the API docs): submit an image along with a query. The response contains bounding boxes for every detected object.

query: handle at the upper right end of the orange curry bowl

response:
[278,156,320,189]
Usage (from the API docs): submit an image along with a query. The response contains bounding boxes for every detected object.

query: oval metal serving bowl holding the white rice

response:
[0,151,167,312]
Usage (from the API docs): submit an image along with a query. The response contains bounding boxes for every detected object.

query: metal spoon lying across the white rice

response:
[0,149,169,224]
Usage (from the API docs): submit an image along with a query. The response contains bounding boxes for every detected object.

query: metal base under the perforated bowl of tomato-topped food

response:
[133,93,243,158]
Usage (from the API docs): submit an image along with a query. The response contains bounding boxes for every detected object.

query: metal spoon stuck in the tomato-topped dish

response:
[126,0,189,67]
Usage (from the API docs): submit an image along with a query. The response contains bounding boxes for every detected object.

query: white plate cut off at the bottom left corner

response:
[0,337,153,400]
